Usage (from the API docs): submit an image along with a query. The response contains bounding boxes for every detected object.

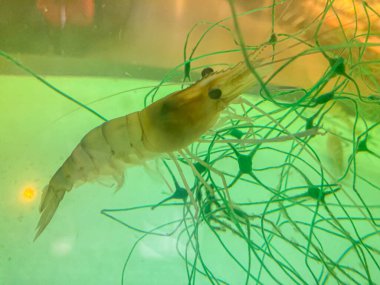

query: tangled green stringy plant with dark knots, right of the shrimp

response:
[1,0,380,284]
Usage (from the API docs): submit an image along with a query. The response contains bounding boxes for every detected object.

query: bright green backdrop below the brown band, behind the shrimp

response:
[0,76,380,284]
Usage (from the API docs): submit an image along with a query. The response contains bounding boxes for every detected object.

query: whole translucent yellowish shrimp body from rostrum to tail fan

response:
[35,56,262,239]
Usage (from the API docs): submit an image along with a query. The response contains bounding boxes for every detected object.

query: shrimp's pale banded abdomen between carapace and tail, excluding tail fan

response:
[65,110,152,183]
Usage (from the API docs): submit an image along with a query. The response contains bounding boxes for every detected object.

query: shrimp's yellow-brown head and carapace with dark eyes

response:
[140,63,255,153]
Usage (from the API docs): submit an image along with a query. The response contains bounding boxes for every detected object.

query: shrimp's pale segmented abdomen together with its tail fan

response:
[35,112,158,239]
